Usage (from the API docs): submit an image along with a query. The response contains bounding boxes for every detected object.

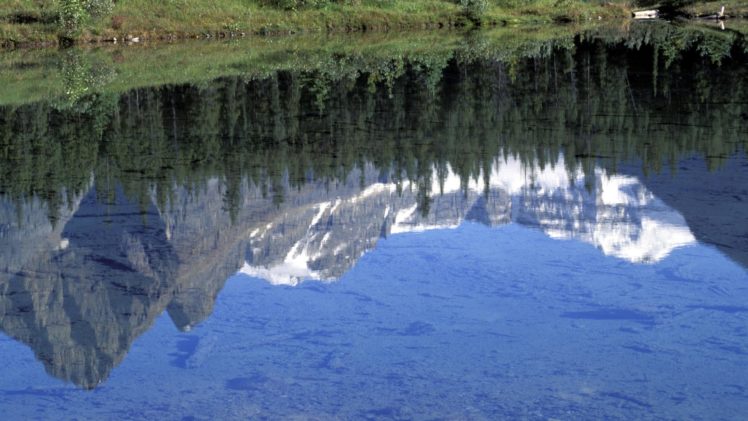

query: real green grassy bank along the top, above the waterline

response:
[0,0,628,47]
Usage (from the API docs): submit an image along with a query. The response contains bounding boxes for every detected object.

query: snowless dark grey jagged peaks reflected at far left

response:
[0,187,229,388]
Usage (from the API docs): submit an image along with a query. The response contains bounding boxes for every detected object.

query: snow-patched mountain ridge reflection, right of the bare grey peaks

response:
[240,157,696,285]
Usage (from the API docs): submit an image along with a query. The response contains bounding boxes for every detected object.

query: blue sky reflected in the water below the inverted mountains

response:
[0,222,748,419]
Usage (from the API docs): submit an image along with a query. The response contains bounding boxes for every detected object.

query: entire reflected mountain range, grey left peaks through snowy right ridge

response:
[0,153,695,388]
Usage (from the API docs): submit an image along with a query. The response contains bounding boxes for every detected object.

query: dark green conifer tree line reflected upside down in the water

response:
[0,27,748,223]
